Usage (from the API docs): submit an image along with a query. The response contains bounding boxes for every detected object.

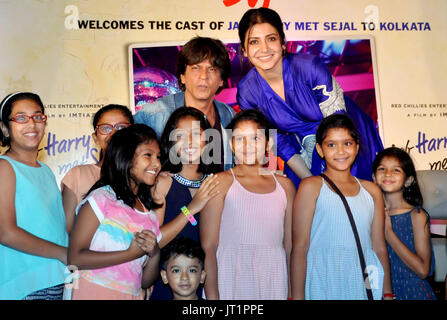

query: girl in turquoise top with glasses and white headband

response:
[0,92,68,300]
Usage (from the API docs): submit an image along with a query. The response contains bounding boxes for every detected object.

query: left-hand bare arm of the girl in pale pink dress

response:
[200,172,233,300]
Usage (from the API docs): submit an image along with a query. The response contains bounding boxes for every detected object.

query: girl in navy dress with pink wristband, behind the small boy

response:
[150,107,217,300]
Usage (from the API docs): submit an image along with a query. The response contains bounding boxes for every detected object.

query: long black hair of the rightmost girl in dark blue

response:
[372,147,424,207]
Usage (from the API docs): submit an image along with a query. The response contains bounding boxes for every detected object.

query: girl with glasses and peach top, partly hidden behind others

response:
[61,104,134,234]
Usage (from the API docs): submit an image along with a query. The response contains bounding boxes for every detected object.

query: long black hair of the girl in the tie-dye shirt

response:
[86,124,161,210]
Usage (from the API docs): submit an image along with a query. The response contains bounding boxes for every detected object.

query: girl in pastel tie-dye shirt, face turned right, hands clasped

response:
[68,124,161,300]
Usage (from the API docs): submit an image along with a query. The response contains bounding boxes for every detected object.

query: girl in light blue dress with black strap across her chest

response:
[290,114,391,300]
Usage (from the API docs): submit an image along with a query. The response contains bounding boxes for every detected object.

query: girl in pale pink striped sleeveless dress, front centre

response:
[200,109,295,300]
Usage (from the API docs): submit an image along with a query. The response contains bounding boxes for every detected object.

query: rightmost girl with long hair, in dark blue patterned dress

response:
[373,147,436,300]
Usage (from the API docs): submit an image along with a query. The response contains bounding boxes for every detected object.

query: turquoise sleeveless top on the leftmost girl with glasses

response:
[0,156,69,300]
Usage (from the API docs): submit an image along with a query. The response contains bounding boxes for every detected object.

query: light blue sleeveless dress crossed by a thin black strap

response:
[305,178,384,300]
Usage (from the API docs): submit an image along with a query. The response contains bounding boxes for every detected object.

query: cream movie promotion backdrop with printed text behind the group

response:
[0,0,447,185]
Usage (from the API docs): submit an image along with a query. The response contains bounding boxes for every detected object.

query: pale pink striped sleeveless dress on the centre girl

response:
[216,169,287,300]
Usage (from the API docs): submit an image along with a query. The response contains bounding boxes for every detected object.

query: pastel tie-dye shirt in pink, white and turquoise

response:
[78,186,161,296]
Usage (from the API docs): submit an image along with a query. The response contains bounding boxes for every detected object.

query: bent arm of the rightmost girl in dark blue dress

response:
[385,209,431,279]
